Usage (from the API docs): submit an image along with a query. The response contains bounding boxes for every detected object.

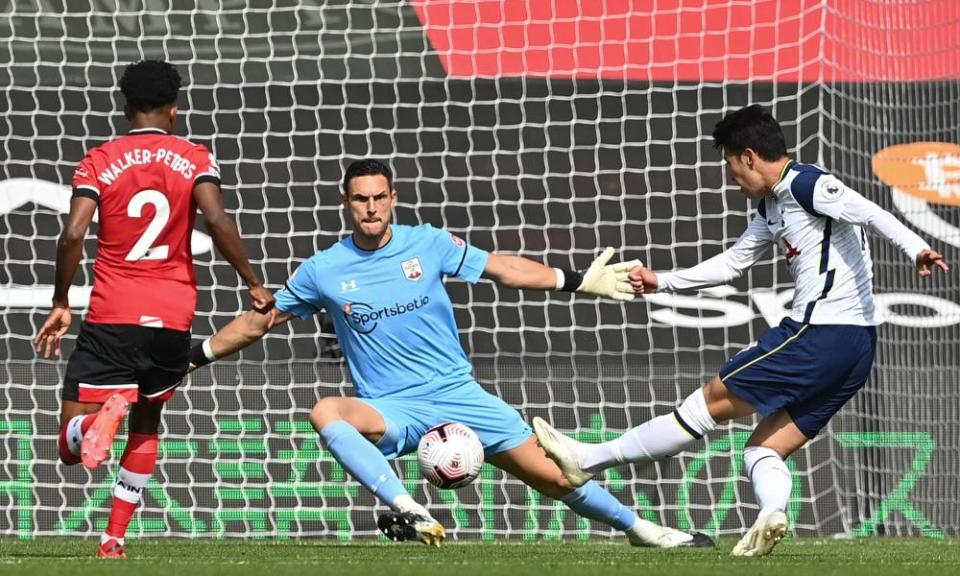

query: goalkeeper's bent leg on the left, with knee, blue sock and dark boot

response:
[310,397,445,546]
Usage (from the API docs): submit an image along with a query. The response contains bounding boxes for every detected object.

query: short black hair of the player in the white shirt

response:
[713,104,787,162]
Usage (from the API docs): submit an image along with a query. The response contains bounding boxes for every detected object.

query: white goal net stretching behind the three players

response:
[0,0,960,540]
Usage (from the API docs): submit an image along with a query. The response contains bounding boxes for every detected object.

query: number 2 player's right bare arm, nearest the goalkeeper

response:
[193,182,274,313]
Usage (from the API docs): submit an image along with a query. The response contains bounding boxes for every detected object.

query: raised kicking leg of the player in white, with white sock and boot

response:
[533,377,755,486]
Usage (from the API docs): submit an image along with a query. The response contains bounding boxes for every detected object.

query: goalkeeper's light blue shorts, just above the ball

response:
[358,380,533,460]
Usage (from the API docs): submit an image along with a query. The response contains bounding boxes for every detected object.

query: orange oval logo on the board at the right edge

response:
[873,142,960,206]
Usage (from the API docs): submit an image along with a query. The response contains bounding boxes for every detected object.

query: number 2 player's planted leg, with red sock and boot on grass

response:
[97,398,163,558]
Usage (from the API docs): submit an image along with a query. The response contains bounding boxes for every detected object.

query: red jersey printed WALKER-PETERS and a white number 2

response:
[73,129,220,330]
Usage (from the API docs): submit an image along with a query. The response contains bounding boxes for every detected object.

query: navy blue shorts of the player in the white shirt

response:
[720,318,877,438]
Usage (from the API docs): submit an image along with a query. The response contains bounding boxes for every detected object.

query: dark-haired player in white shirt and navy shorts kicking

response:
[534,105,948,556]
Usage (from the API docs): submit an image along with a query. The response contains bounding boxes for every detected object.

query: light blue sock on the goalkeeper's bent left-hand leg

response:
[320,420,410,507]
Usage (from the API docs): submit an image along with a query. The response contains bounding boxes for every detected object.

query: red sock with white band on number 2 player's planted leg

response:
[106,434,159,539]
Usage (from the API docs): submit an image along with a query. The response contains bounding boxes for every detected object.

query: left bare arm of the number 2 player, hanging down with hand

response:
[33,196,97,358]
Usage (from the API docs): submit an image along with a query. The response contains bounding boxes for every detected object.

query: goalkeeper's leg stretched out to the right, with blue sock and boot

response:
[488,436,713,548]
